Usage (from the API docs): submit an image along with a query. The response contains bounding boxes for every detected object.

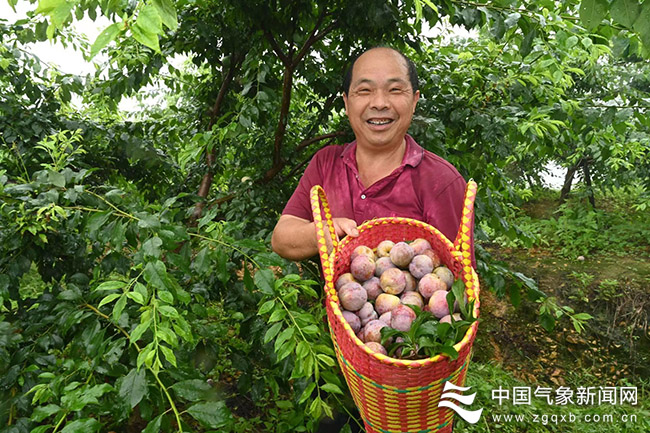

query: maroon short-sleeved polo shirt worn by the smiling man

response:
[282,135,473,258]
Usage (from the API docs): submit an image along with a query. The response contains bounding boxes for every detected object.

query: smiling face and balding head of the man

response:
[343,48,420,149]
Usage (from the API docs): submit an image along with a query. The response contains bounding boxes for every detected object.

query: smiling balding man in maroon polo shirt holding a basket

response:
[271,47,466,260]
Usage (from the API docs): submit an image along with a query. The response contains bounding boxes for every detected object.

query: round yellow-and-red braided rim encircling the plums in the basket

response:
[325,217,480,368]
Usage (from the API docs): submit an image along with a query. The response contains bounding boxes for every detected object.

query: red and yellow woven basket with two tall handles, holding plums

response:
[311,181,479,433]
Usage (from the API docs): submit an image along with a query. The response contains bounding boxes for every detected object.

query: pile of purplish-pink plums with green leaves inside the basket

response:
[336,238,471,358]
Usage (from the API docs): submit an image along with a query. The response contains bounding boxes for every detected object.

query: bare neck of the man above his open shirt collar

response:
[356,138,406,188]
